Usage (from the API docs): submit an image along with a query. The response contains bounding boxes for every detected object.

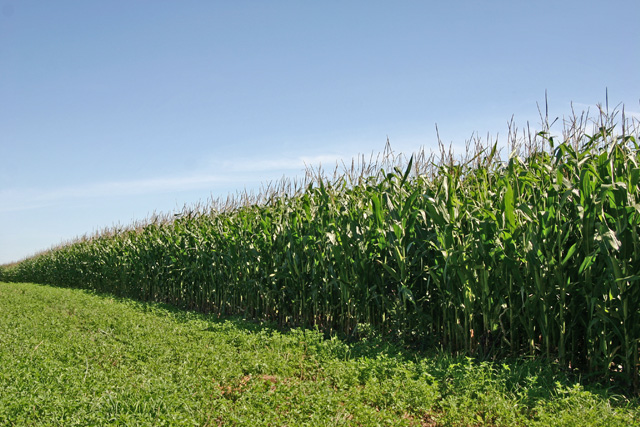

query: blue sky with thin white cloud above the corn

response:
[0,0,640,264]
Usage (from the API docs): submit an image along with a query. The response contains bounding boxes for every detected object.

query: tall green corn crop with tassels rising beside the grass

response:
[0,106,640,393]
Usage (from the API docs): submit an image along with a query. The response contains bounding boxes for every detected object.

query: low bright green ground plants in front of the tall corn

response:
[0,283,640,426]
